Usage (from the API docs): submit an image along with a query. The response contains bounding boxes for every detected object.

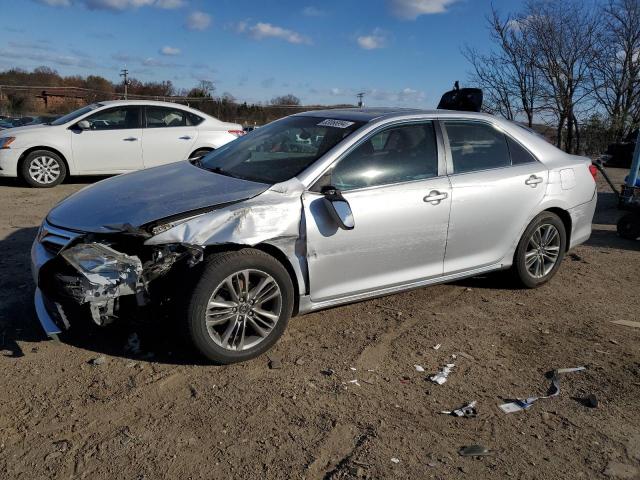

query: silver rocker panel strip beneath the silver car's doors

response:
[298,263,508,315]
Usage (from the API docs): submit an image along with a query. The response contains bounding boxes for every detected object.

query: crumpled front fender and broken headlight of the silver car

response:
[53,179,306,325]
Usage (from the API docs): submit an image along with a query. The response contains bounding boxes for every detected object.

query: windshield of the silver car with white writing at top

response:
[197,116,364,184]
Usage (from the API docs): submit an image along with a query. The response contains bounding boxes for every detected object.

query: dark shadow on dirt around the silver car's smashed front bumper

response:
[0,227,206,365]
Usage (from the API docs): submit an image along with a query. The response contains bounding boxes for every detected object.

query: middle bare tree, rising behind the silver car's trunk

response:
[524,0,601,153]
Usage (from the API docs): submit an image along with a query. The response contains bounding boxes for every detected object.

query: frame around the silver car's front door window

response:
[299,116,447,194]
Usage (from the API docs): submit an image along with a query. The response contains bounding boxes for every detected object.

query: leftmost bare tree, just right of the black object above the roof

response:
[463,8,540,126]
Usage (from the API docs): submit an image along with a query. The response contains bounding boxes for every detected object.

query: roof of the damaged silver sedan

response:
[296,107,495,122]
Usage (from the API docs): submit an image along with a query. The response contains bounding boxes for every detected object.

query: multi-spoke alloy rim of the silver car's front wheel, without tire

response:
[204,269,282,351]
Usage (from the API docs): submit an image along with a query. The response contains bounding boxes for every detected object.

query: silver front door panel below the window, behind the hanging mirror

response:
[303,177,451,301]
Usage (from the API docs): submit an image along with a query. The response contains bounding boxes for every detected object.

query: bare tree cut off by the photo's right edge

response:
[591,0,640,141]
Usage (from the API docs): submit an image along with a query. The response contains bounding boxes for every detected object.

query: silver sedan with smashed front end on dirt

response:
[32,109,596,363]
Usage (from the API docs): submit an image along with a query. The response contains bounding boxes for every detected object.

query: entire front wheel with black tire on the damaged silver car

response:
[186,248,294,364]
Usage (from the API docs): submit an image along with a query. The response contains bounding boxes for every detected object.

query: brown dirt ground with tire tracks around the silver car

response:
[0,169,640,480]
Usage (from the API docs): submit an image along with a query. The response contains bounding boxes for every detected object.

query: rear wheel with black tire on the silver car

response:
[513,212,567,288]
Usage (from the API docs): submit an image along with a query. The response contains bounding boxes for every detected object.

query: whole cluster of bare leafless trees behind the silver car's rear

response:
[463,0,640,153]
